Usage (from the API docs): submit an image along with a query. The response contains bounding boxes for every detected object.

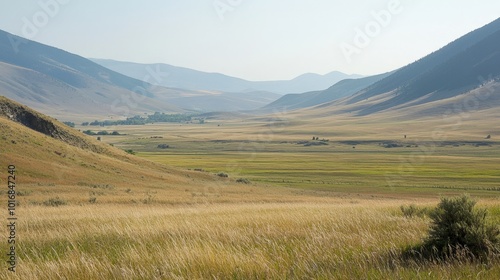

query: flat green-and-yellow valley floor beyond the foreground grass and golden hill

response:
[105,122,500,198]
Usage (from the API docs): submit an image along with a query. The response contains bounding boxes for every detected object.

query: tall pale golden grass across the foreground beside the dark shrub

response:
[0,200,500,279]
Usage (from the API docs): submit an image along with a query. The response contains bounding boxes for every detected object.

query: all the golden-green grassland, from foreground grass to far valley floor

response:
[0,115,500,279]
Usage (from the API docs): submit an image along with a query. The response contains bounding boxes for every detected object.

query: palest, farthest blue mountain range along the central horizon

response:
[91,59,362,94]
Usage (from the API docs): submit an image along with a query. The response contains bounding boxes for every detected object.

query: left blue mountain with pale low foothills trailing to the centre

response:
[0,30,286,119]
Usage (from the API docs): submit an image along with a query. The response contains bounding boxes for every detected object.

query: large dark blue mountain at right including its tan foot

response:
[286,19,500,120]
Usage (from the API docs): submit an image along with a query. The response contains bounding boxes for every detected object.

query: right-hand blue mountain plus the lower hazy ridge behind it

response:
[264,13,500,116]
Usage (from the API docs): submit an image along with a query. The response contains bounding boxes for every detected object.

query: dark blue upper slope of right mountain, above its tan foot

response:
[337,19,500,115]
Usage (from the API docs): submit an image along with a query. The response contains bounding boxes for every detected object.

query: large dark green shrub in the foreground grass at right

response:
[425,195,500,259]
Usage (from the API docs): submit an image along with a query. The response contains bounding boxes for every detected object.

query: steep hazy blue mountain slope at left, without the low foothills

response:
[0,31,182,119]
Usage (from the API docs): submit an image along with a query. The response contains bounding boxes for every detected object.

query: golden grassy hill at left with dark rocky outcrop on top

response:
[0,97,222,197]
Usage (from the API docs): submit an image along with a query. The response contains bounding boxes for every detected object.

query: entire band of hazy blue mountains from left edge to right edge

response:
[0,16,500,122]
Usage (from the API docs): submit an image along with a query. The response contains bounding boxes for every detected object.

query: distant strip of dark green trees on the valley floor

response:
[82,112,193,126]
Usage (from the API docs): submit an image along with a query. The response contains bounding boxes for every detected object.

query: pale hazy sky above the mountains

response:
[0,0,500,81]
